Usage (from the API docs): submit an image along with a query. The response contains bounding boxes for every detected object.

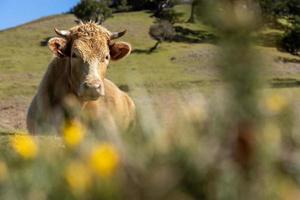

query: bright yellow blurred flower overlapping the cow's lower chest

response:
[63,121,85,148]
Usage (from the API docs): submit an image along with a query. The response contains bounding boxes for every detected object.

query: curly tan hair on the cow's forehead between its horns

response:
[70,22,111,61]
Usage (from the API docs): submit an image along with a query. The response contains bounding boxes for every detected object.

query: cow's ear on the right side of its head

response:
[109,42,131,60]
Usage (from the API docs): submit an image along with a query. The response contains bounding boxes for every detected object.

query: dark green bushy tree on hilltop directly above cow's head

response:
[71,0,112,22]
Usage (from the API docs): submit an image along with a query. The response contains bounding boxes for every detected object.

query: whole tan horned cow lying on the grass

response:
[27,22,135,134]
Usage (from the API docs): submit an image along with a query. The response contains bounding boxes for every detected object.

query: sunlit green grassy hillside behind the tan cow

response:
[0,5,300,131]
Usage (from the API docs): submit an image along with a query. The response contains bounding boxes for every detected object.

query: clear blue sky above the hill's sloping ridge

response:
[0,0,79,30]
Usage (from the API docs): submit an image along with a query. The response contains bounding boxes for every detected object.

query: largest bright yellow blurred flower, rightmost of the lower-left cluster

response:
[90,143,119,177]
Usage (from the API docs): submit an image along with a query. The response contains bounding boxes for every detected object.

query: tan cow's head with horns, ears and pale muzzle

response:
[49,22,131,100]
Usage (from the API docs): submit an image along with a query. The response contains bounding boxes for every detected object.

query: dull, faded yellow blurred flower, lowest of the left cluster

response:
[65,161,91,193]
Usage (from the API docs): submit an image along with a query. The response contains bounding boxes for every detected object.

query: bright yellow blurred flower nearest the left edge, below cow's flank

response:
[11,134,38,159]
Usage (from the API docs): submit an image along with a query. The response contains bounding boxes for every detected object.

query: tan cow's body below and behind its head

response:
[27,21,135,134]
